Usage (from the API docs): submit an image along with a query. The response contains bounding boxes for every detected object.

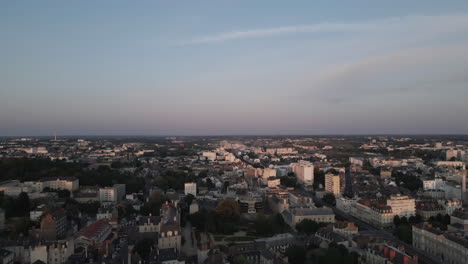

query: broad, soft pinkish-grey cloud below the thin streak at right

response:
[299,44,468,104]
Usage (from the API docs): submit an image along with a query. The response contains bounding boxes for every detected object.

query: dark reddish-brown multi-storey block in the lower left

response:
[40,209,67,240]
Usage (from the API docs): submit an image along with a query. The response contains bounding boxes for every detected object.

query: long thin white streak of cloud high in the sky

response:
[186,14,468,44]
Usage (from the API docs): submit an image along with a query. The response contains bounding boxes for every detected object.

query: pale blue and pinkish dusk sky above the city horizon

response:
[0,0,468,136]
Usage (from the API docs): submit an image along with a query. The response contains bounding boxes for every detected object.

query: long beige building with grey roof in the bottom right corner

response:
[413,223,468,264]
